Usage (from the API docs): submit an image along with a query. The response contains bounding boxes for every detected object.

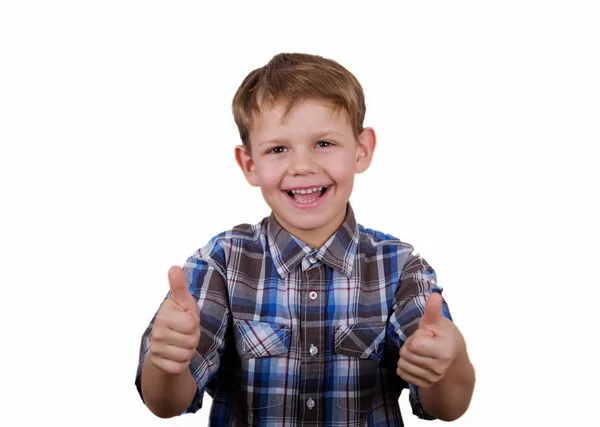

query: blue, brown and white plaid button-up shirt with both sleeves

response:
[136,204,450,427]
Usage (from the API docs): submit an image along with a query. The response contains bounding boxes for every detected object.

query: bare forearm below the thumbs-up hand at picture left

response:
[142,360,198,418]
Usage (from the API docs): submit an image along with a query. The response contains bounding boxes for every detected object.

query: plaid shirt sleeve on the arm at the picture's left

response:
[135,243,231,413]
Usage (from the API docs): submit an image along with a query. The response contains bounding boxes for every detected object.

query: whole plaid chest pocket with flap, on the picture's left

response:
[233,318,292,416]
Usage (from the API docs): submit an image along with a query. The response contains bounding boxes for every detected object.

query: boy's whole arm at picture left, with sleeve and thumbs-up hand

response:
[136,249,230,418]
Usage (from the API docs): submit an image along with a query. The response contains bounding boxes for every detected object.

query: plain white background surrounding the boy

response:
[0,0,600,426]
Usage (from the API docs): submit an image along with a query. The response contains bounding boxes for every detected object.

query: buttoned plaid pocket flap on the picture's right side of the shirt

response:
[334,322,386,360]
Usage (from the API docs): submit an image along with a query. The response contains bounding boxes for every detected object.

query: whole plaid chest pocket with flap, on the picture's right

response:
[334,322,386,412]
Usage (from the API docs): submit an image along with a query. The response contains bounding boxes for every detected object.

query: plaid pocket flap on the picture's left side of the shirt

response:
[233,318,291,359]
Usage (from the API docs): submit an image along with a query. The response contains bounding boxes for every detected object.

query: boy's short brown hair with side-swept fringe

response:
[232,53,366,148]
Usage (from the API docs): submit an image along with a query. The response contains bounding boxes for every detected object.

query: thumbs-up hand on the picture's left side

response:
[148,266,200,375]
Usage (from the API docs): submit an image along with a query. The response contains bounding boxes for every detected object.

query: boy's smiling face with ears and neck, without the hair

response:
[236,99,375,247]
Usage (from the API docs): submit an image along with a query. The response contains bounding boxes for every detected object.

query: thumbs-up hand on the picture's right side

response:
[396,293,464,388]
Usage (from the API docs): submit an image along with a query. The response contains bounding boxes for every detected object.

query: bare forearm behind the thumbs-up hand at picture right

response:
[419,350,475,421]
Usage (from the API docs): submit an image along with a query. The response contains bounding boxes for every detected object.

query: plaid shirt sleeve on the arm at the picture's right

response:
[387,251,452,420]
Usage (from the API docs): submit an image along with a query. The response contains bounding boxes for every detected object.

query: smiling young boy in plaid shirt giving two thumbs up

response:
[136,54,475,427]
